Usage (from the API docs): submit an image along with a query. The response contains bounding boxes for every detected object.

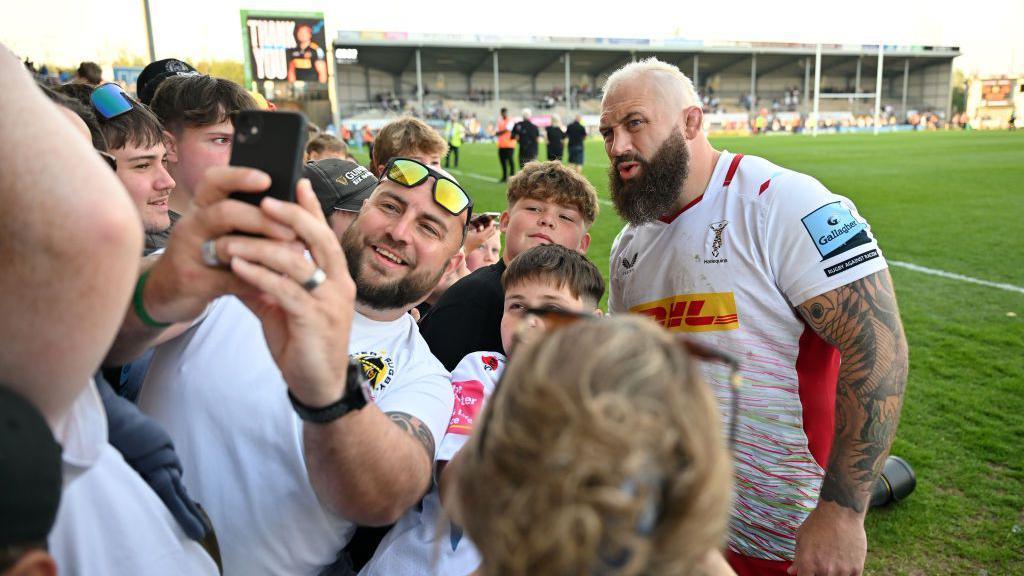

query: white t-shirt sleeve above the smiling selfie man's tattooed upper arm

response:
[376,354,454,457]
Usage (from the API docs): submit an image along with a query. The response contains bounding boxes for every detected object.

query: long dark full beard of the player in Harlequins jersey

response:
[608,130,690,225]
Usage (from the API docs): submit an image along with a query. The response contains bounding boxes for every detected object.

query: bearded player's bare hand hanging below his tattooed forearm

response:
[788,501,867,576]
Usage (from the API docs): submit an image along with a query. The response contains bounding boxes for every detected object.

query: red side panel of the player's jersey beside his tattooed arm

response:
[797,323,840,469]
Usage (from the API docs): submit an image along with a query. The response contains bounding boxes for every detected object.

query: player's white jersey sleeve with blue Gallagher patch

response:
[761,173,887,306]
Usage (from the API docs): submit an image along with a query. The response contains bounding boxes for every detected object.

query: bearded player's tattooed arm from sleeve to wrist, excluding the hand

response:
[799,271,907,512]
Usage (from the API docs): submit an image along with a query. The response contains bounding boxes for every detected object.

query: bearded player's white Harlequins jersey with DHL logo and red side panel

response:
[608,152,887,560]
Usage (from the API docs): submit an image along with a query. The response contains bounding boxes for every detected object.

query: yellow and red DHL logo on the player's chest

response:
[630,292,739,332]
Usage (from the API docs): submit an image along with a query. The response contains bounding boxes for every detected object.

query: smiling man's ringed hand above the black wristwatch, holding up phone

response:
[225,179,355,408]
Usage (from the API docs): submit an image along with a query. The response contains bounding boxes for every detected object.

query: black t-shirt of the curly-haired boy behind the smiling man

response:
[420,260,505,372]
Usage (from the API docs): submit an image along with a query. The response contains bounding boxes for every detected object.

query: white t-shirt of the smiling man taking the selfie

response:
[139,296,453,576]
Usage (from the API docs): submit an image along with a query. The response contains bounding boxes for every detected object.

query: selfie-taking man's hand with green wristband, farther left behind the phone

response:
[143,166,296,322]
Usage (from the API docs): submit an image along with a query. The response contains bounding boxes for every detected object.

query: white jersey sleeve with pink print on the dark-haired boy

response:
[437,353,505,461]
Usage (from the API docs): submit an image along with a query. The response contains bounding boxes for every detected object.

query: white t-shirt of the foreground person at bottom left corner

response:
[49,382,218,576]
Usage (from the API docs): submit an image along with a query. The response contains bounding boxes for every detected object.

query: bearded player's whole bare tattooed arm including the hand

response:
[794,270,907,576]
